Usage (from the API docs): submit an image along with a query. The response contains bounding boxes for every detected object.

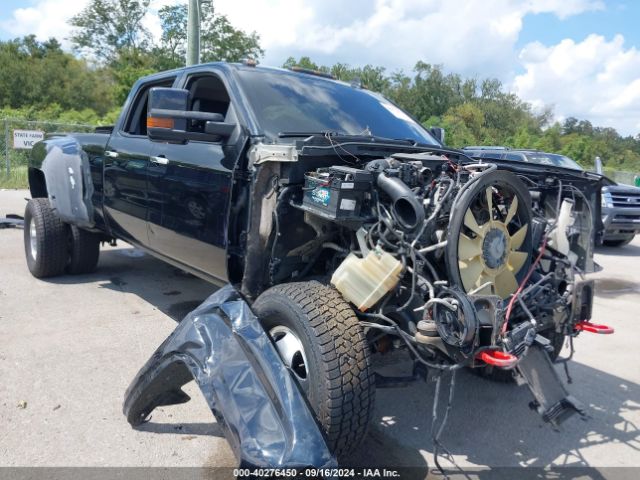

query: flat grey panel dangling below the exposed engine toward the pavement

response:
[517,343,588,428]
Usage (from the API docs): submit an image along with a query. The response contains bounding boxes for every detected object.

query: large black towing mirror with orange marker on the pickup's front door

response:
[147,87,236,143]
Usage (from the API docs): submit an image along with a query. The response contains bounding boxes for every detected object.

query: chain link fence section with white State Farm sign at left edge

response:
[0,118,95,188]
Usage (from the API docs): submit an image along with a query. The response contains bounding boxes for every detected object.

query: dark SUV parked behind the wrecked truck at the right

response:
[463,147,640,247]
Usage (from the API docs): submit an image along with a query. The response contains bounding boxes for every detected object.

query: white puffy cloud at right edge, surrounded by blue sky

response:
[513,35,640,135]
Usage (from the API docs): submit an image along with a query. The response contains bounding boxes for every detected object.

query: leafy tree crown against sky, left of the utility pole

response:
[70,0,151,64]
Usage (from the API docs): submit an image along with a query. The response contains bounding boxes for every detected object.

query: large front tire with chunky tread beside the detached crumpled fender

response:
[253,281,375,458]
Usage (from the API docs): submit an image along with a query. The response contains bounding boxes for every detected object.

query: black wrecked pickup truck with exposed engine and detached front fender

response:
[25,63,611,465]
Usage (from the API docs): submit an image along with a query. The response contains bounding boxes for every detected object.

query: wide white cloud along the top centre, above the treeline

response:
[215,0,604,78]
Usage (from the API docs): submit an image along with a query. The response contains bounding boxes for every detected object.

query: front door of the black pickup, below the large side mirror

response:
[149,72,240,281]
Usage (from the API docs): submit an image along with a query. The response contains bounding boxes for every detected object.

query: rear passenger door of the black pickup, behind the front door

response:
[103,76,175,246]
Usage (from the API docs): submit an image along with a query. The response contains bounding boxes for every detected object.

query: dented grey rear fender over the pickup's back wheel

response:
[30,136,94,228]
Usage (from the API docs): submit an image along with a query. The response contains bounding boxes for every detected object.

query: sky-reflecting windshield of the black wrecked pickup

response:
[238,70,439,145]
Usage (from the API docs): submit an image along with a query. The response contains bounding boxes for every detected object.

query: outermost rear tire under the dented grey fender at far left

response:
[24,198,69,278]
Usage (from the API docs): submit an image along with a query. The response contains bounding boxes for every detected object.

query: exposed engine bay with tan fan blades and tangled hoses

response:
[236,138,599,422]
